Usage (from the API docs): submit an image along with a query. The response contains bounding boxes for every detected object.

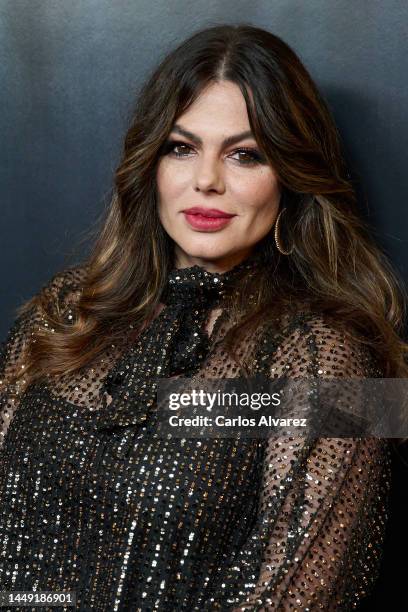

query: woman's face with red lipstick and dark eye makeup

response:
[157,81,281,272]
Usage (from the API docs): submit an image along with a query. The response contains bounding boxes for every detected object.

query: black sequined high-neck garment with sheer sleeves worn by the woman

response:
[0,257,390,612]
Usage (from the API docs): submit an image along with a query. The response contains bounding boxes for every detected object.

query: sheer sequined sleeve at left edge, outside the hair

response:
[0,268,84,448]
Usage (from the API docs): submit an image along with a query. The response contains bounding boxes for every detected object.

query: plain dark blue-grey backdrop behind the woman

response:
[0,0,408,610]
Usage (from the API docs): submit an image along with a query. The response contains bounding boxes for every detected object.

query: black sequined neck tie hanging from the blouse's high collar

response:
[98,253,261,456]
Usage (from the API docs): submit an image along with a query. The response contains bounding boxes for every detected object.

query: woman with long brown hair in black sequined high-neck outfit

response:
[0,25,407,611]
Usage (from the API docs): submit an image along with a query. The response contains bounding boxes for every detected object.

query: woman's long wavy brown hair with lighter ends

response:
[14,24,408,390]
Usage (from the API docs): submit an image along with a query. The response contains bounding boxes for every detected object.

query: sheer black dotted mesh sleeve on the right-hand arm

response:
[201,317,390,612]
